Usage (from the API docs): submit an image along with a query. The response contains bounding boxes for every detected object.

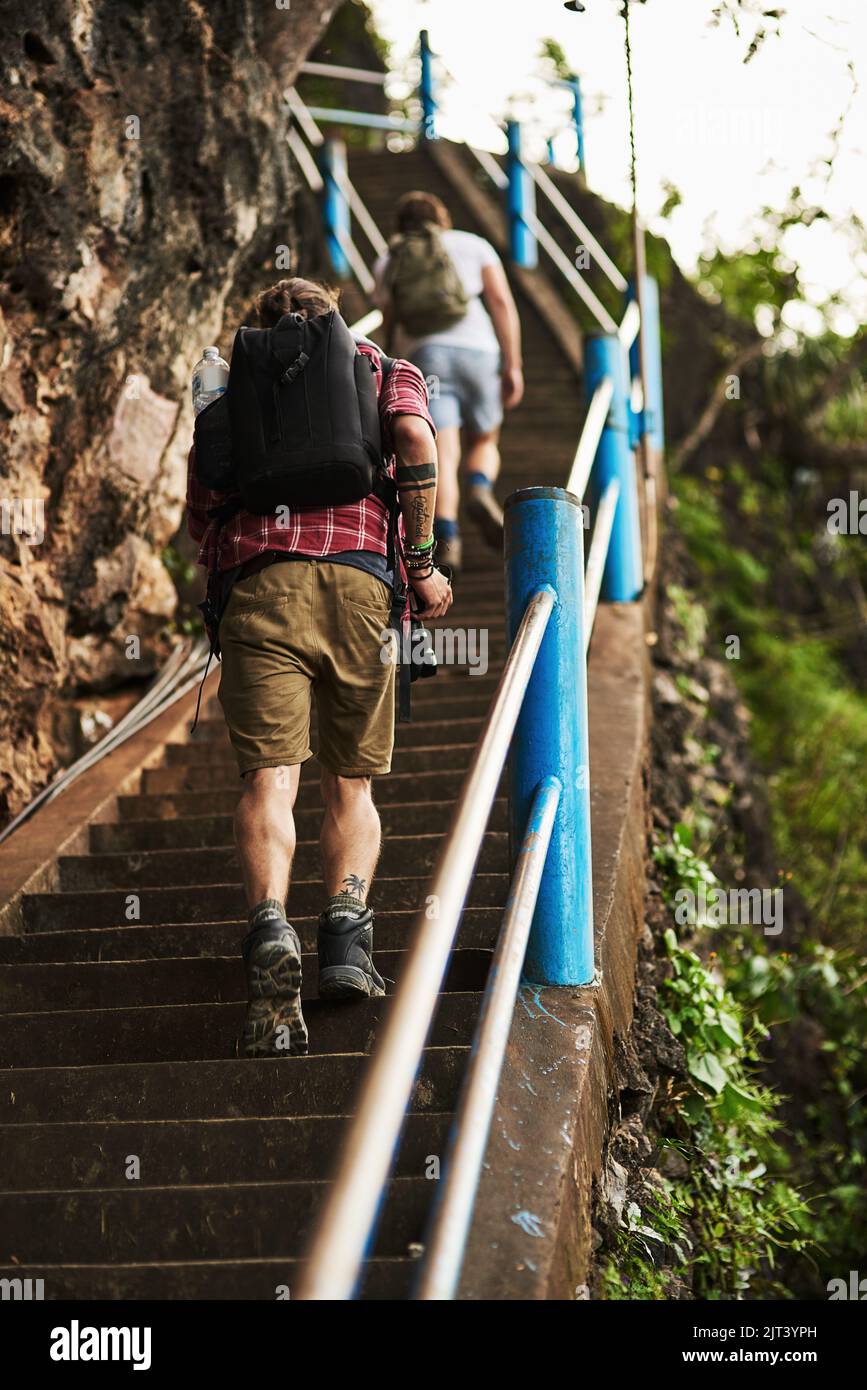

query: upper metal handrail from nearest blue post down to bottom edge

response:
[297,585,556,1300]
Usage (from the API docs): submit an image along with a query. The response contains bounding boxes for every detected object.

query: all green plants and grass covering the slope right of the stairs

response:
[636,539,867,1297]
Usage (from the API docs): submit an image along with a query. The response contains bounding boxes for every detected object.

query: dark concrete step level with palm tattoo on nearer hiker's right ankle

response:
[21,873,509,931]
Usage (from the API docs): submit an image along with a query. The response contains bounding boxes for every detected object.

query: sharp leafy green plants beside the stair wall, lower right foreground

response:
[602,824,816,1300]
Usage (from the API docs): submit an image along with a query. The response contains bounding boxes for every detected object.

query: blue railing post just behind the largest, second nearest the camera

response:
[584,334,643,603]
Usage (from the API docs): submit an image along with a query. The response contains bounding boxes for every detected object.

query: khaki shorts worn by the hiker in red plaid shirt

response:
[220,559,395,777]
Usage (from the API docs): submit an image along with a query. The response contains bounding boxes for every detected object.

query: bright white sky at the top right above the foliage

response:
[368,0,867,332]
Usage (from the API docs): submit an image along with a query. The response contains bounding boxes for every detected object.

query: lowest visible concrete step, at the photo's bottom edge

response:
[0,1257,418,1302]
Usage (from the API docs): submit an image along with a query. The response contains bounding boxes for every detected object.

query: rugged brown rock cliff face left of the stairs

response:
[0,0,336,823]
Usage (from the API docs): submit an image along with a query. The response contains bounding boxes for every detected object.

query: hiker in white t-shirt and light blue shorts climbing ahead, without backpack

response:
[374,192,524,571]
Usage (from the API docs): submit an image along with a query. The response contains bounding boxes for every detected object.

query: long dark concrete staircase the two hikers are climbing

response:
[0,138,581,1300]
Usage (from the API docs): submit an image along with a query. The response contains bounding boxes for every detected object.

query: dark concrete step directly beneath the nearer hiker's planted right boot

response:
[0,989,484,1061]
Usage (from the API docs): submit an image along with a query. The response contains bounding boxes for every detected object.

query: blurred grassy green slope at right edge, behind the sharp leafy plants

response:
[674,478,867,944]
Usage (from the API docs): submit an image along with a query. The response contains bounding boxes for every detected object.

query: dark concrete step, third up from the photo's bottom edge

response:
[0,1113,452,1193]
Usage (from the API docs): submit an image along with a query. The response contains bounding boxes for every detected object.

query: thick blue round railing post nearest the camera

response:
[504,488,593,984]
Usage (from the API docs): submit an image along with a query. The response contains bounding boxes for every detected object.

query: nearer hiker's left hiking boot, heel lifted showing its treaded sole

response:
[239,917,307,1056]
